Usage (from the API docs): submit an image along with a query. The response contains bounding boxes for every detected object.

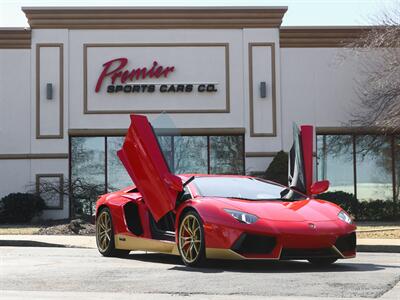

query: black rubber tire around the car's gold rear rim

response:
[96,207,130,257]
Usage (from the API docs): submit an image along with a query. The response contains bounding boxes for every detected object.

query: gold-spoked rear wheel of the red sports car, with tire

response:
[96,207,129,257]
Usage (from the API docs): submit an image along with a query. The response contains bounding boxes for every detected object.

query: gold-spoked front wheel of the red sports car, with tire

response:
[178,210,206,267]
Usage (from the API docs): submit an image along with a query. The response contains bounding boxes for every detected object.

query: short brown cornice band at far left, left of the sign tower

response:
[0,28,31,49]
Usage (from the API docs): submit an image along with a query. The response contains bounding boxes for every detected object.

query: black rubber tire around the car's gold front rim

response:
[178,210,206,267]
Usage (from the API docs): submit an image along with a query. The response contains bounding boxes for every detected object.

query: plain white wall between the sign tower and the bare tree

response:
[281,48,360,151]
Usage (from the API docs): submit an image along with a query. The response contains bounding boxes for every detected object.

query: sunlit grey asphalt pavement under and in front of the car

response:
[0,247,400,300]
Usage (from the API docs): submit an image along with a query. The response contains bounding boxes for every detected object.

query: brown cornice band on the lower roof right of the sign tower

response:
[279,26,373,48]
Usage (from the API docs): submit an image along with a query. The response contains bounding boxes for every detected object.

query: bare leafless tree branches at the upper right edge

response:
[348,2,400,133]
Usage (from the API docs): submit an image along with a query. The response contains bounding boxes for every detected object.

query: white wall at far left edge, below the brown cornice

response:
[0,49,31,203]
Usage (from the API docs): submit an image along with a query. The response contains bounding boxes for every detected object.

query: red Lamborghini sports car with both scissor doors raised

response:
[96,115,356,266]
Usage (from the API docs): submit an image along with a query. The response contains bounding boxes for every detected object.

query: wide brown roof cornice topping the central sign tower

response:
[22,7,287,29]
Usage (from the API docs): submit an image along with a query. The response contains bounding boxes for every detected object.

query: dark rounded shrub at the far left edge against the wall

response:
[0,193,45,223]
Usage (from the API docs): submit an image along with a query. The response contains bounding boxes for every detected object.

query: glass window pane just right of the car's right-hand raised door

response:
[317,135,354,194]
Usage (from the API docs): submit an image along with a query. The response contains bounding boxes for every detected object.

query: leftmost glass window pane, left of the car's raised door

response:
[71,137,105,215]
